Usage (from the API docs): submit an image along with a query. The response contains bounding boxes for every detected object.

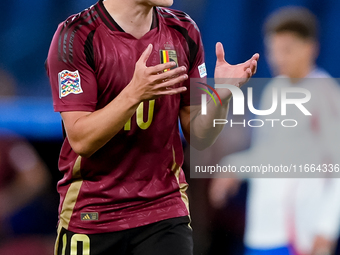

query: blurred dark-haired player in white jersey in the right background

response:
[210,7,340,254]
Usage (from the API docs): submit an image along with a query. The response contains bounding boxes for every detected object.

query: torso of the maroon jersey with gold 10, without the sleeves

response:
[58,5,194,232]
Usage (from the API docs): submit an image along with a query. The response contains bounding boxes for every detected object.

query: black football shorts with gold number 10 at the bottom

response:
[55,216,193,255]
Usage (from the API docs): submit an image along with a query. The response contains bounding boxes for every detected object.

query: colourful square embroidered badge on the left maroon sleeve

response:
[58,70,83,98]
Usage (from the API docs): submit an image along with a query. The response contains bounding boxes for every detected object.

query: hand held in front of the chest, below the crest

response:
[128,44,188,102]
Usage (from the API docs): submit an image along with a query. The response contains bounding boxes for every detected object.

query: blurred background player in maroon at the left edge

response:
[0,69,53,255]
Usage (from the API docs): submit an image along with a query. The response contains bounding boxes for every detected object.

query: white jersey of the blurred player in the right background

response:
[220,69,340,253]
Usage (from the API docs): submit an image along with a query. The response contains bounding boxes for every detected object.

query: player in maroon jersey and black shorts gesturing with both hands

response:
[46,0,259,255]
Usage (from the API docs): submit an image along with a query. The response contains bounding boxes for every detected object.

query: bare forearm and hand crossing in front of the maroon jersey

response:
[62,44,188,157]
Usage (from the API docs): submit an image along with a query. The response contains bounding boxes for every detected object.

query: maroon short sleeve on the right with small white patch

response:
[181,21,207,107]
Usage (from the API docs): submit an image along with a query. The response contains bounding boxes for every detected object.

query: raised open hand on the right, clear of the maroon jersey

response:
[214,42,260,99]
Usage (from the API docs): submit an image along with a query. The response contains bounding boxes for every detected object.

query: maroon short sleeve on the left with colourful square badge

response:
[46,22,97,112]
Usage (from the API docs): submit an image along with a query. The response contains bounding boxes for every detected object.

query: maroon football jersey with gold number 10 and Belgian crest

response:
[46,0,206,234]
